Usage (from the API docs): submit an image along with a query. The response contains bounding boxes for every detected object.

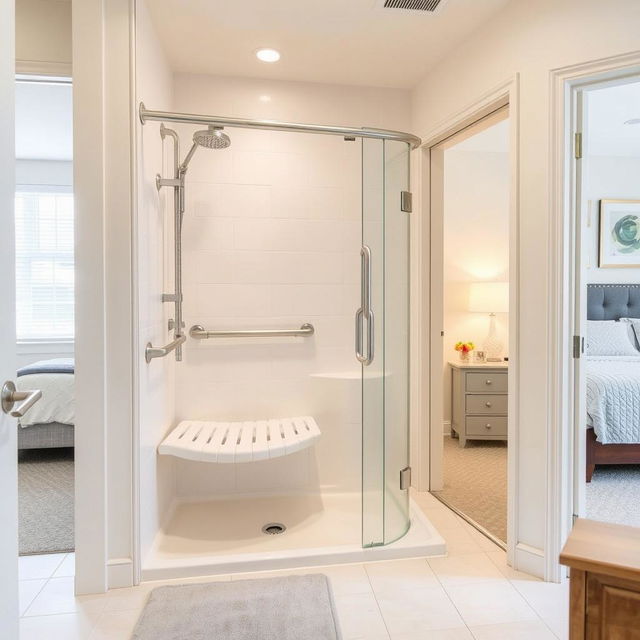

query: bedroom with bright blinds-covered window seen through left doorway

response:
[15,74,75,584]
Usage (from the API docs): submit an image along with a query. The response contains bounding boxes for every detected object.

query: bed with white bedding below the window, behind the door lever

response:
[16,358,75,450]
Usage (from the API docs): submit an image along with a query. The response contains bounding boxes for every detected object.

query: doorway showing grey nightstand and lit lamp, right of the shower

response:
[431,107,511,548]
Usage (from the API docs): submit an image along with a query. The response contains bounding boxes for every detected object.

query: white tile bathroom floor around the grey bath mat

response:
[20,494,569,640]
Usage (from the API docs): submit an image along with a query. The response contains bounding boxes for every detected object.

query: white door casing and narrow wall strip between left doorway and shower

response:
[72,0,135,594]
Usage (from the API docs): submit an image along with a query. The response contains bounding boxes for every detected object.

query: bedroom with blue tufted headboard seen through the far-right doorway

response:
[574,72,640,527]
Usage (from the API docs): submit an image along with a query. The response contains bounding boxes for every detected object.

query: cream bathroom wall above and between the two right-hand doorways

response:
[412,0,640,573]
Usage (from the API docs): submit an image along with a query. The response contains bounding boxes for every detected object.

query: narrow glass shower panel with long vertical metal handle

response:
[356,138,384,547]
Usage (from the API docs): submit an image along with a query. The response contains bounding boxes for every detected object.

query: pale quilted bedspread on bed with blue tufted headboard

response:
[586,355,640,444]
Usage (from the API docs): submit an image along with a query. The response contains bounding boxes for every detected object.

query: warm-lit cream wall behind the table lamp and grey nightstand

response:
[443,147,509,426]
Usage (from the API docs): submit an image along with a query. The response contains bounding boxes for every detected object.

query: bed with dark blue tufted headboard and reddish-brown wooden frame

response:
[585,284,640,482]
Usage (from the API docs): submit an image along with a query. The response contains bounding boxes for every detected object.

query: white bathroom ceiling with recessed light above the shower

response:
[148,0,508,88]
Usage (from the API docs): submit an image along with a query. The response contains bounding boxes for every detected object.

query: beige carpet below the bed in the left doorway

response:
[18,448,74,556]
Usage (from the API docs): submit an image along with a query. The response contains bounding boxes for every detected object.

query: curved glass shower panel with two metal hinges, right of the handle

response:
[383,140,410,544]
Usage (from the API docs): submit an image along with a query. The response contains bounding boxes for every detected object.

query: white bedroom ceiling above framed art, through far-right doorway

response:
[586,82,640,158]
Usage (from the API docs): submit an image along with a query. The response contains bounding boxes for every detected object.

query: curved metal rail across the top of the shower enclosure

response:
[138,102,422,149]
